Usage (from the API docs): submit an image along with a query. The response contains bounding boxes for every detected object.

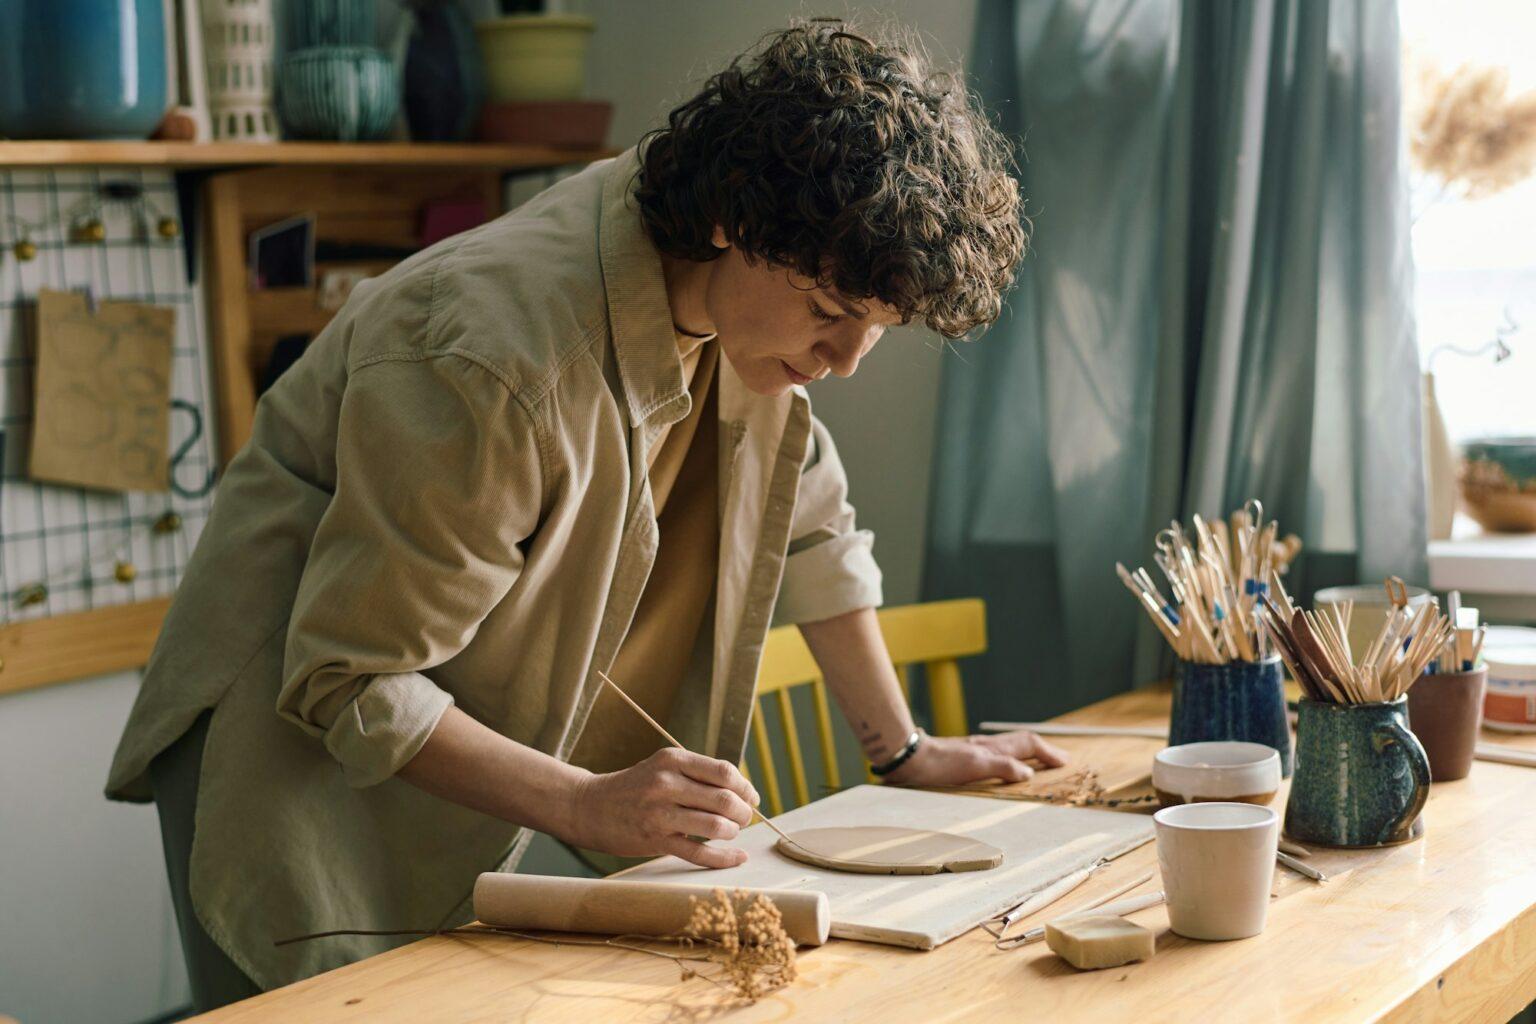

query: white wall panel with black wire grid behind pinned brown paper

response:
[0,169,217,623]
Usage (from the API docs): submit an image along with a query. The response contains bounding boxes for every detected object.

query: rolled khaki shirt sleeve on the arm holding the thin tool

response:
[276,353,542,786]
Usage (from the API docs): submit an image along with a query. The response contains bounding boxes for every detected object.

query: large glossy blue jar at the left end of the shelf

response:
[0,0,167,138]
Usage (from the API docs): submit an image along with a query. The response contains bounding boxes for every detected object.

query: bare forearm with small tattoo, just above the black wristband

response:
[800,608,914,765]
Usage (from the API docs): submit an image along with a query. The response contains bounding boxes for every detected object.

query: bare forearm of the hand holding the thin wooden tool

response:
[399,708,591,838]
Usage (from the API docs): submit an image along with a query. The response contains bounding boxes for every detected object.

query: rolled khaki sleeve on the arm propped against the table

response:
[774,416,883,625]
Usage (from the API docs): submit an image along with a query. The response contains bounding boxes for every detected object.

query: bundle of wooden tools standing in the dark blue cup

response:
[1115,499,1301,665]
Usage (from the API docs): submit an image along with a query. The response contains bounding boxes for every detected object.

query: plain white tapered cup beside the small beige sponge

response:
[1152,803,1279,941]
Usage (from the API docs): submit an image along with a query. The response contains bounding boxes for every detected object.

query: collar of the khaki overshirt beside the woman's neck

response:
[598,149,690,427]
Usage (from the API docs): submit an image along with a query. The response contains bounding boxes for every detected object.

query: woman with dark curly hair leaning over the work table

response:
[96,23,1061,1009]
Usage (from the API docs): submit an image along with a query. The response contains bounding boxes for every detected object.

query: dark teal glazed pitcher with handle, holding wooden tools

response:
[1286,697,1430,847]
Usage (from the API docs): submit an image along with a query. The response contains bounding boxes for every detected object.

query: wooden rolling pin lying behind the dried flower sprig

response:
[475,872,833,946]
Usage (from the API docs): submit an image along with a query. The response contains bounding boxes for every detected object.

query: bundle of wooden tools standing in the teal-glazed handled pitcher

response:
[1258,576,1458,705]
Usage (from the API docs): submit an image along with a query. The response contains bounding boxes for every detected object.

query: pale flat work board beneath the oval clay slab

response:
[624,786,1152,949]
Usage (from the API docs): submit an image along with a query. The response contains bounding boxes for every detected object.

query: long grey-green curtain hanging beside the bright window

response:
[925,0,1425,718]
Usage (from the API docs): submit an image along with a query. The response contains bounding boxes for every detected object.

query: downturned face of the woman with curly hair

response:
[703,246,902,396]
